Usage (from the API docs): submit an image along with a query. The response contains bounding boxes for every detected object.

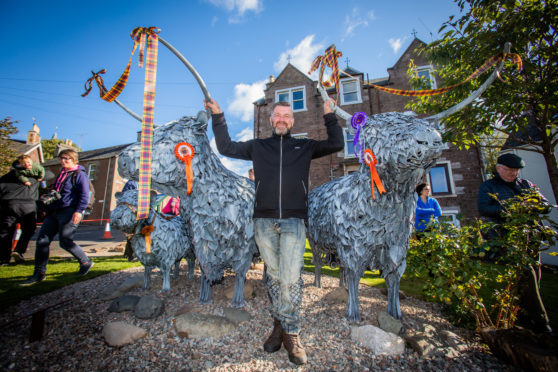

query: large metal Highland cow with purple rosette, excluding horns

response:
[308,113,442,321]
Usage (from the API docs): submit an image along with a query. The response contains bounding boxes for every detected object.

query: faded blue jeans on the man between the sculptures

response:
[254,218,306,334]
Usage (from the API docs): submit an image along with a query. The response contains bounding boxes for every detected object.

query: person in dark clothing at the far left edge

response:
[0,170,39,265]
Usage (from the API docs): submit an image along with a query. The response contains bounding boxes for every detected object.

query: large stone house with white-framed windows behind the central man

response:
[254,38,484,223]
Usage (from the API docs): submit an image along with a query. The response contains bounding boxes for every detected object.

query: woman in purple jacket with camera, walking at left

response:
[20,149,93,285]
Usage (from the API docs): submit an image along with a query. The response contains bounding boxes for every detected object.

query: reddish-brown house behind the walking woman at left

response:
[43,144,130,225]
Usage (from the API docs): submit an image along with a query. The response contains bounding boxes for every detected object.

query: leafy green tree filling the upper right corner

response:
[409,0,558,200]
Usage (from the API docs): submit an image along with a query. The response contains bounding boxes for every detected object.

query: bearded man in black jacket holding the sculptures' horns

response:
[205,100,344,364]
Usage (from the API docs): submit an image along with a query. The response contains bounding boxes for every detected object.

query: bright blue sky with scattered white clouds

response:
[0,0,459,175]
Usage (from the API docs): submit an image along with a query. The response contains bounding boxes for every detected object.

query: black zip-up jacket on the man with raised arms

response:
[212,113,344,219]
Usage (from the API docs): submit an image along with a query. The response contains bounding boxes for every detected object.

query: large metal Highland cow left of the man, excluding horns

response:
[118,112,256,307]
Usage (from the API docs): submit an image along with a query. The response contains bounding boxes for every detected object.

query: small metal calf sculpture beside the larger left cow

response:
[110,190,196,292]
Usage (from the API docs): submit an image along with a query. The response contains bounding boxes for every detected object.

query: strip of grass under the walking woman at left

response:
[0,256,141,310]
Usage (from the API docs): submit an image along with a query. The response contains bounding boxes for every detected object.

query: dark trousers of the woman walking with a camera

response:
[35,207,89,274]
